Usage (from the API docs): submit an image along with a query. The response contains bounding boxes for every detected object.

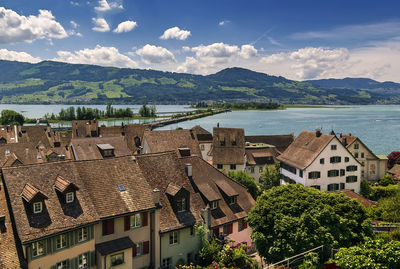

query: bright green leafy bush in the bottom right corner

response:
[331,239,400,269]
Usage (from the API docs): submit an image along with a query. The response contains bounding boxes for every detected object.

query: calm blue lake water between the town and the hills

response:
[0,104,400,154]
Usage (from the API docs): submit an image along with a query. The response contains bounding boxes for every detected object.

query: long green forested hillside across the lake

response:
[0,61,400,104]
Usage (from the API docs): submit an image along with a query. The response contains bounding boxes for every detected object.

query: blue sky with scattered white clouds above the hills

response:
[0,0,400,82]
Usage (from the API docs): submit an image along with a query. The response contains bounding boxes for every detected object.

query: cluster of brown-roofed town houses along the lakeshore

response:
[0,119,400,269]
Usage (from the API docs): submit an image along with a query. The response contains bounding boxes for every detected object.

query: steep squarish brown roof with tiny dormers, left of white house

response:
[212,127,245,164]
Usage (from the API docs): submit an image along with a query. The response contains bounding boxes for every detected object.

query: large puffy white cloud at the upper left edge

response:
[0,7,68,44]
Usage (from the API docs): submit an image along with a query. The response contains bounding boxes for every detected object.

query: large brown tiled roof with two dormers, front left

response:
[2,157,155,243]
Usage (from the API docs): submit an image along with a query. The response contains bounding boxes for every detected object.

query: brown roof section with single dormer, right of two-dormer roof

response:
[136,151,205,232]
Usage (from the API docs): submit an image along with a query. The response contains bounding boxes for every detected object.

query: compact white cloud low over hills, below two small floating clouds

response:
[136,44,175,64]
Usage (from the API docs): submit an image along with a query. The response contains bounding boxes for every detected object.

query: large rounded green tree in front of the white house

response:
[248,184,372,263]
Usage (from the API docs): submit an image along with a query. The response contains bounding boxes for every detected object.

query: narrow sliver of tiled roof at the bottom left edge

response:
[0,180,27,269]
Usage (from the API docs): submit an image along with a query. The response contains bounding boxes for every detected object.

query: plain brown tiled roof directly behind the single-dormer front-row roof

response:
[143,129,201,156]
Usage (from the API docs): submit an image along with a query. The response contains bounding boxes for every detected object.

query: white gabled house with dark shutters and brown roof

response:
[277,130,362,193]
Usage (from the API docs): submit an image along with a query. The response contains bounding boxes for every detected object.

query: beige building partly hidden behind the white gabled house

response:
[339,134,388,182]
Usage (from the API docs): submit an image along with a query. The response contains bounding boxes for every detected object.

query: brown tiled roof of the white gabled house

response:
[277,131,339,169]
